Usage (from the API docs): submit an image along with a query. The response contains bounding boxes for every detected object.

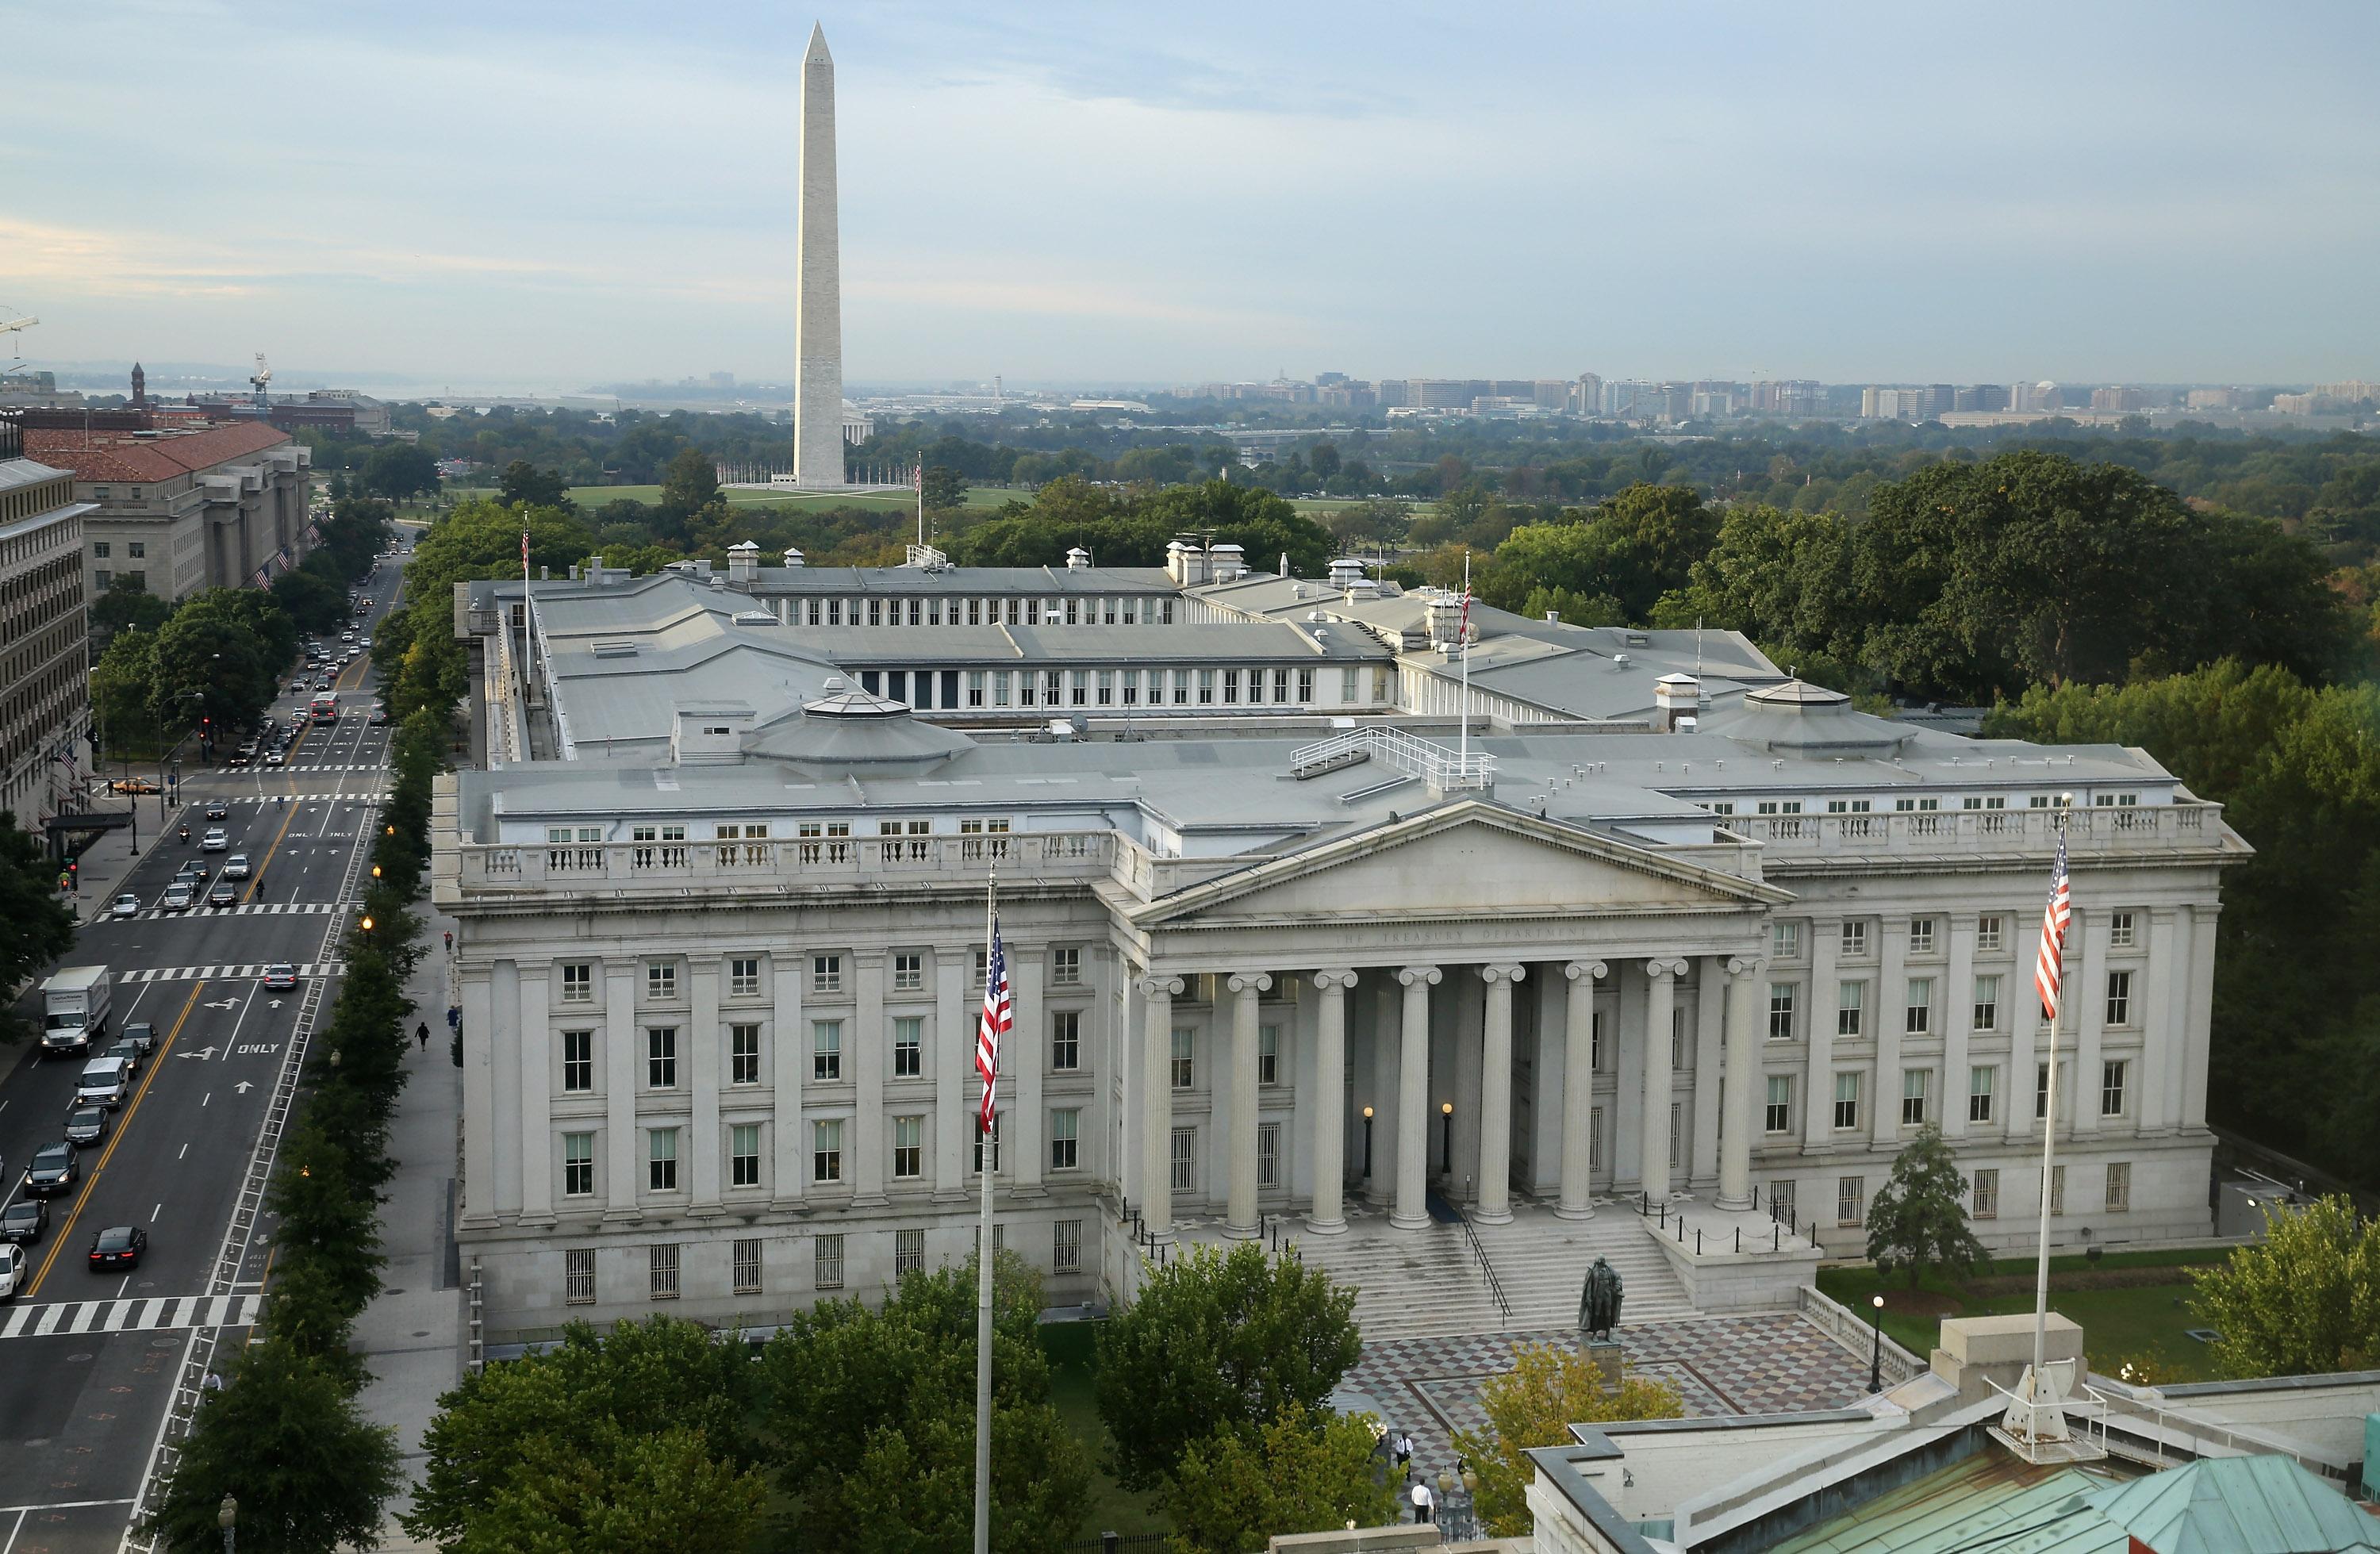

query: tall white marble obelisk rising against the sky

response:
[793,26,843,485]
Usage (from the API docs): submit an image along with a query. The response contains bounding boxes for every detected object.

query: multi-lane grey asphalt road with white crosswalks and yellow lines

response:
[0,562,395,1554]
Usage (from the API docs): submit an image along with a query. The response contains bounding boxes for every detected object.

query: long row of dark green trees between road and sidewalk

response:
[148,714,447,1554]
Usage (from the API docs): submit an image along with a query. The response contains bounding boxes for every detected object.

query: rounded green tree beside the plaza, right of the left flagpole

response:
[1097,1242,1364,1490]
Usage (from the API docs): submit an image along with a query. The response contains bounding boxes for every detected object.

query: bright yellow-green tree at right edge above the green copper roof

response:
[2192,1195,2380,1378]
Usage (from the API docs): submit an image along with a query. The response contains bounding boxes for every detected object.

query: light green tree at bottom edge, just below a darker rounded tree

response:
[1161,1409,1397,1554]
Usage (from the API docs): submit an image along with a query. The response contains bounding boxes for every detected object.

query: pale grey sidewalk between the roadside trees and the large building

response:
[355,900,464,1554]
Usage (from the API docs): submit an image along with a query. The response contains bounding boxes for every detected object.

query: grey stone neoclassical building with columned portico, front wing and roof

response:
[436,557,2244,1340]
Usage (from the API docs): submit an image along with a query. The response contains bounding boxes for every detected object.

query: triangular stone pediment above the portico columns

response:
[1130,800,1792,923]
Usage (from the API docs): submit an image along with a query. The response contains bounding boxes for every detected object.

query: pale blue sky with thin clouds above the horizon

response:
[0,0,2380,390]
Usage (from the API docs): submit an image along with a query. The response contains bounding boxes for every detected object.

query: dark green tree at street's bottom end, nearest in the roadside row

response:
[145,1337,402,1554]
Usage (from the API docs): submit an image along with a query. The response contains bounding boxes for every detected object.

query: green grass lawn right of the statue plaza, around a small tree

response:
[1818,1247,2230,1380]
